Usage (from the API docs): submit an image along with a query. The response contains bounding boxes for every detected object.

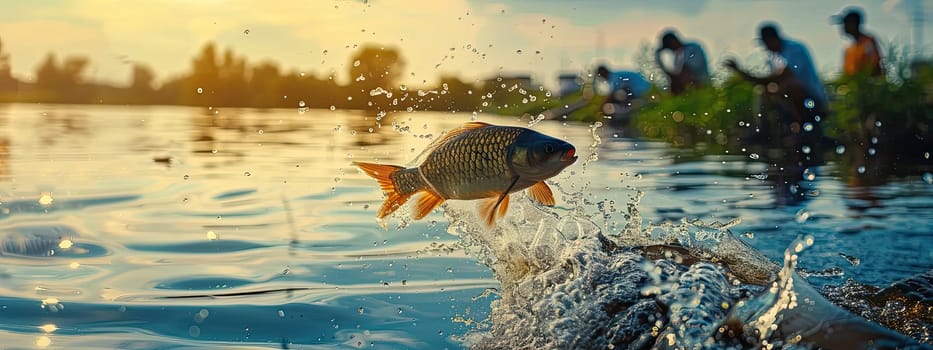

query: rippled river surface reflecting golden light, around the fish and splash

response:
[0,105,933,348]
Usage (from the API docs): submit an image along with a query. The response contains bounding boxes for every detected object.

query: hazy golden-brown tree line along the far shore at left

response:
[0,41,544,112]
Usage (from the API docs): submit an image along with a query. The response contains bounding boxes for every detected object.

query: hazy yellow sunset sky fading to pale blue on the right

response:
[0,0,933,87]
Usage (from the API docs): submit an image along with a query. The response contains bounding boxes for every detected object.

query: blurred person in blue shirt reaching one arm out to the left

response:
[724,23,828,148]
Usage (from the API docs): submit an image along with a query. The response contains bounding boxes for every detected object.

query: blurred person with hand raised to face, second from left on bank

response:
[654,30,709,95]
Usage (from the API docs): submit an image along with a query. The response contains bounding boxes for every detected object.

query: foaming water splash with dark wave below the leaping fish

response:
[445,176,924,349]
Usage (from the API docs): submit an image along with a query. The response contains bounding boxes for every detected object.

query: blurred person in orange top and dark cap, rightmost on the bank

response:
[833,7,884,77]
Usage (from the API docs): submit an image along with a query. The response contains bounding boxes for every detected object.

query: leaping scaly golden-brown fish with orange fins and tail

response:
[354,122,577,226]
